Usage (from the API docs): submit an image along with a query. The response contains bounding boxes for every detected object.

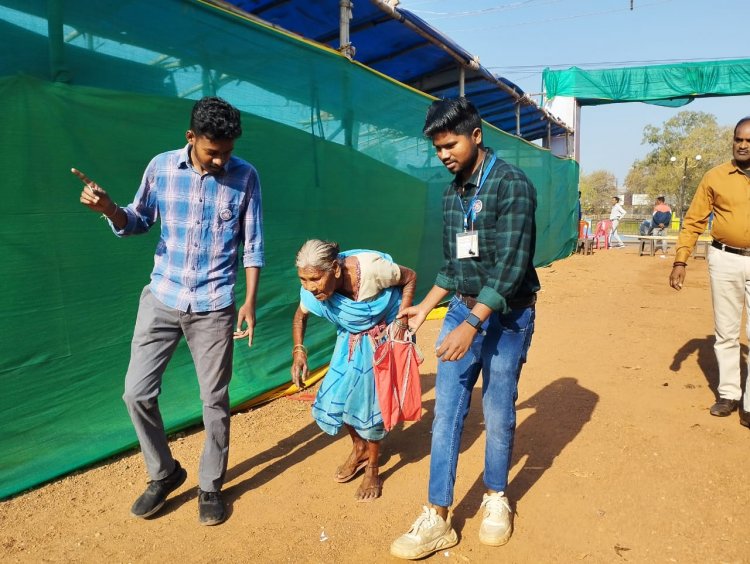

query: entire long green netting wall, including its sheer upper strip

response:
[0,0,578,498]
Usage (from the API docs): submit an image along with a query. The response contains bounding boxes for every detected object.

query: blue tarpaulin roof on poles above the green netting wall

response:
[222,0,569,141]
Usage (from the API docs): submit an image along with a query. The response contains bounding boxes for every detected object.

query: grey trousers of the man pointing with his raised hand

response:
[122,286,235,492]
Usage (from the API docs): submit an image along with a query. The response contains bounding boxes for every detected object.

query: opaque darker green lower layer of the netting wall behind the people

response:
[0,77,446,497]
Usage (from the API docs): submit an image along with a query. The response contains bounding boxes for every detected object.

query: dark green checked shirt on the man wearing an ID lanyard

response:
[435,148,540,313]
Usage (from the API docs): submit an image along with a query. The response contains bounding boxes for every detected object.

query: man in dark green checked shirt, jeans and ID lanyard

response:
[391,98,539,559]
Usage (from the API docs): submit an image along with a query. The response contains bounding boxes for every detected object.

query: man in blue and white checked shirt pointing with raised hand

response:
[72,97,264,525]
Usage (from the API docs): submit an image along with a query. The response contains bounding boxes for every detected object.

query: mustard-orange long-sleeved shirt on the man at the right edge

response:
[675,160,750,262]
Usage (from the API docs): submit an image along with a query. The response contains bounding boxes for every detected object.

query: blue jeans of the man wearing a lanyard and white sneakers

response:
[428,297,536,507]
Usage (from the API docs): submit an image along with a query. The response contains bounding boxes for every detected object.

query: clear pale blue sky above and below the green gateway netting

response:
[408,0,750,188]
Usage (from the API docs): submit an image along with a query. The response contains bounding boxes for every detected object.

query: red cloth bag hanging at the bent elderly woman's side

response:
[372,323,424,431]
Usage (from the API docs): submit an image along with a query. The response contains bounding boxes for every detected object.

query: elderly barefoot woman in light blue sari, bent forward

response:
[292,239,417,501]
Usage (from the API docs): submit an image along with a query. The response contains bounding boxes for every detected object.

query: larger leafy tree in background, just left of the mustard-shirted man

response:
[625,111,732,217]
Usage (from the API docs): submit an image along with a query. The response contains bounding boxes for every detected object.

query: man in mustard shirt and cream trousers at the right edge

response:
[669,116,750,427]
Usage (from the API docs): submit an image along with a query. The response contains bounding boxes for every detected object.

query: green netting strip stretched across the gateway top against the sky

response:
[542,59,750,107]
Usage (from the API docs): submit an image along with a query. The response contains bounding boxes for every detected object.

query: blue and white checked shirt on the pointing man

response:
[113,145,264,312]
